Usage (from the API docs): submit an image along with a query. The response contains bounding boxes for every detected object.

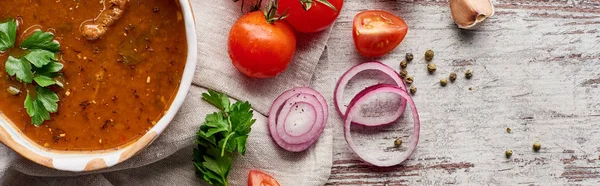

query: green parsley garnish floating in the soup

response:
[0,19,63,126]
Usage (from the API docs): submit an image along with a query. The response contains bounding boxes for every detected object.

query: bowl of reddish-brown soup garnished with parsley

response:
[0,0,197,171]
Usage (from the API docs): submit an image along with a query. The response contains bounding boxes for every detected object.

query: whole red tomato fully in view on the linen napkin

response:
[227,11,296,78]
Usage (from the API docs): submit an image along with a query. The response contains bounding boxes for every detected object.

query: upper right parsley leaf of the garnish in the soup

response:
[21,30,60,52]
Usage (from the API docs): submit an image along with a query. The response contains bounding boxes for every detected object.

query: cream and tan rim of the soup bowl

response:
[0,0,198,172]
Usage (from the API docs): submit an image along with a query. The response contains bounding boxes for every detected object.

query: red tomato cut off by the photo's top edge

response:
[277,0,344,33]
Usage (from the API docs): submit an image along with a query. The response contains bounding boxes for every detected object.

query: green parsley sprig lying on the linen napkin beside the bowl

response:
[193,90,256,186]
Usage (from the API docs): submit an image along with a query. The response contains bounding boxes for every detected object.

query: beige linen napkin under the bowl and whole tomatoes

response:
[0,0,333,185]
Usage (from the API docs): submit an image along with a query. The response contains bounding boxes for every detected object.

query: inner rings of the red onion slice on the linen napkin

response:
[277,94,325,144]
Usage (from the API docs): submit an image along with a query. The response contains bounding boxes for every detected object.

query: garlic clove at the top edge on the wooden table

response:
[450,0,494,29]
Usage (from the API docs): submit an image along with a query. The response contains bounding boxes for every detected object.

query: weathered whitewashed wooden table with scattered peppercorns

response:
[320,0,600,185]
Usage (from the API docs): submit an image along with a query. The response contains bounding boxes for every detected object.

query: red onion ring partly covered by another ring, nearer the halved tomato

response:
[333,62,406,126]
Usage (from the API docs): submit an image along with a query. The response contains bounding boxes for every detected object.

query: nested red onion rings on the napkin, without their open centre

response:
[268,87,329,152]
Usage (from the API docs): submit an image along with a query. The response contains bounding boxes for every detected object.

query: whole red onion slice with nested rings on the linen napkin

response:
[268,87,329,152]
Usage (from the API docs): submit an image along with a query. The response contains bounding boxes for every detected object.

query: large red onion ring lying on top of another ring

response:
[344,85,421,167]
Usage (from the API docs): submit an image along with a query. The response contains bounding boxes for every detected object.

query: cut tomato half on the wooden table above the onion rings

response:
[352,10,408,57]
